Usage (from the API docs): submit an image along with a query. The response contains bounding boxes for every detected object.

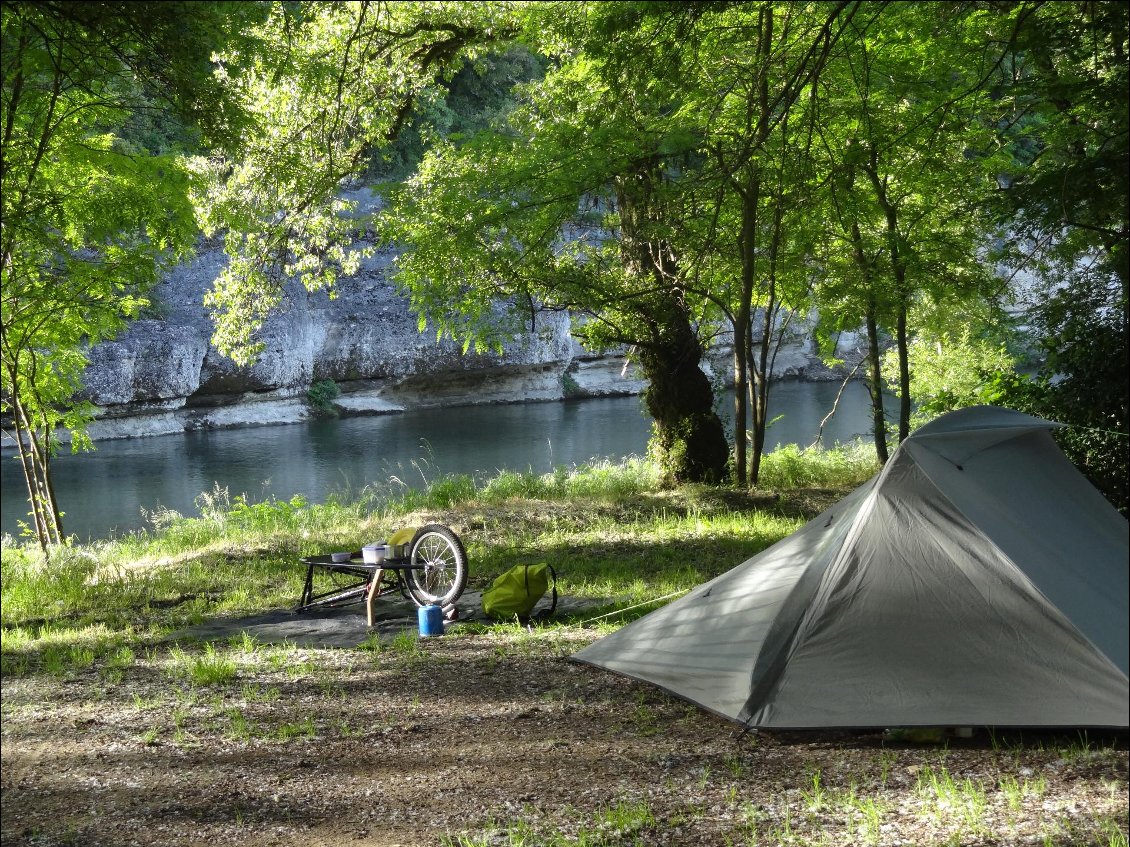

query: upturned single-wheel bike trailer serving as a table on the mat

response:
[295,524,467,626]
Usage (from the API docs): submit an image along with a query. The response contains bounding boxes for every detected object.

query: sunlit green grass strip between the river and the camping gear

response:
[0,448,870,684]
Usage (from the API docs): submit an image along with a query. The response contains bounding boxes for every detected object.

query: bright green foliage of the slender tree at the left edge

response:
[0,2,251,548]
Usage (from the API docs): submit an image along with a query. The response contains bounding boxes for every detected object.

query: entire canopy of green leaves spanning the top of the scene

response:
[0,0,1130,530]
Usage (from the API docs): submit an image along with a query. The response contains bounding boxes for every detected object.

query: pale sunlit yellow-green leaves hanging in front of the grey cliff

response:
[192,2,514,363]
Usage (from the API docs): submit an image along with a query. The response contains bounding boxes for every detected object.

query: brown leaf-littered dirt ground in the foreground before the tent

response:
[0,605,1128,847]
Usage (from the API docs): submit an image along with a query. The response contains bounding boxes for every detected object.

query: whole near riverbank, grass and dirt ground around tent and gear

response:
[0,451,1128,847]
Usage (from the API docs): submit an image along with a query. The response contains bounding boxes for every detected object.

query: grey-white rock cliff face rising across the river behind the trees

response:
[72,198,849,439]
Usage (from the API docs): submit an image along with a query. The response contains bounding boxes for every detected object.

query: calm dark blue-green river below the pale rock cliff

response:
[0,382,868,540]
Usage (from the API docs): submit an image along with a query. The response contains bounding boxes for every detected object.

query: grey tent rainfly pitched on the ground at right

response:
[573,407,1130,730]
